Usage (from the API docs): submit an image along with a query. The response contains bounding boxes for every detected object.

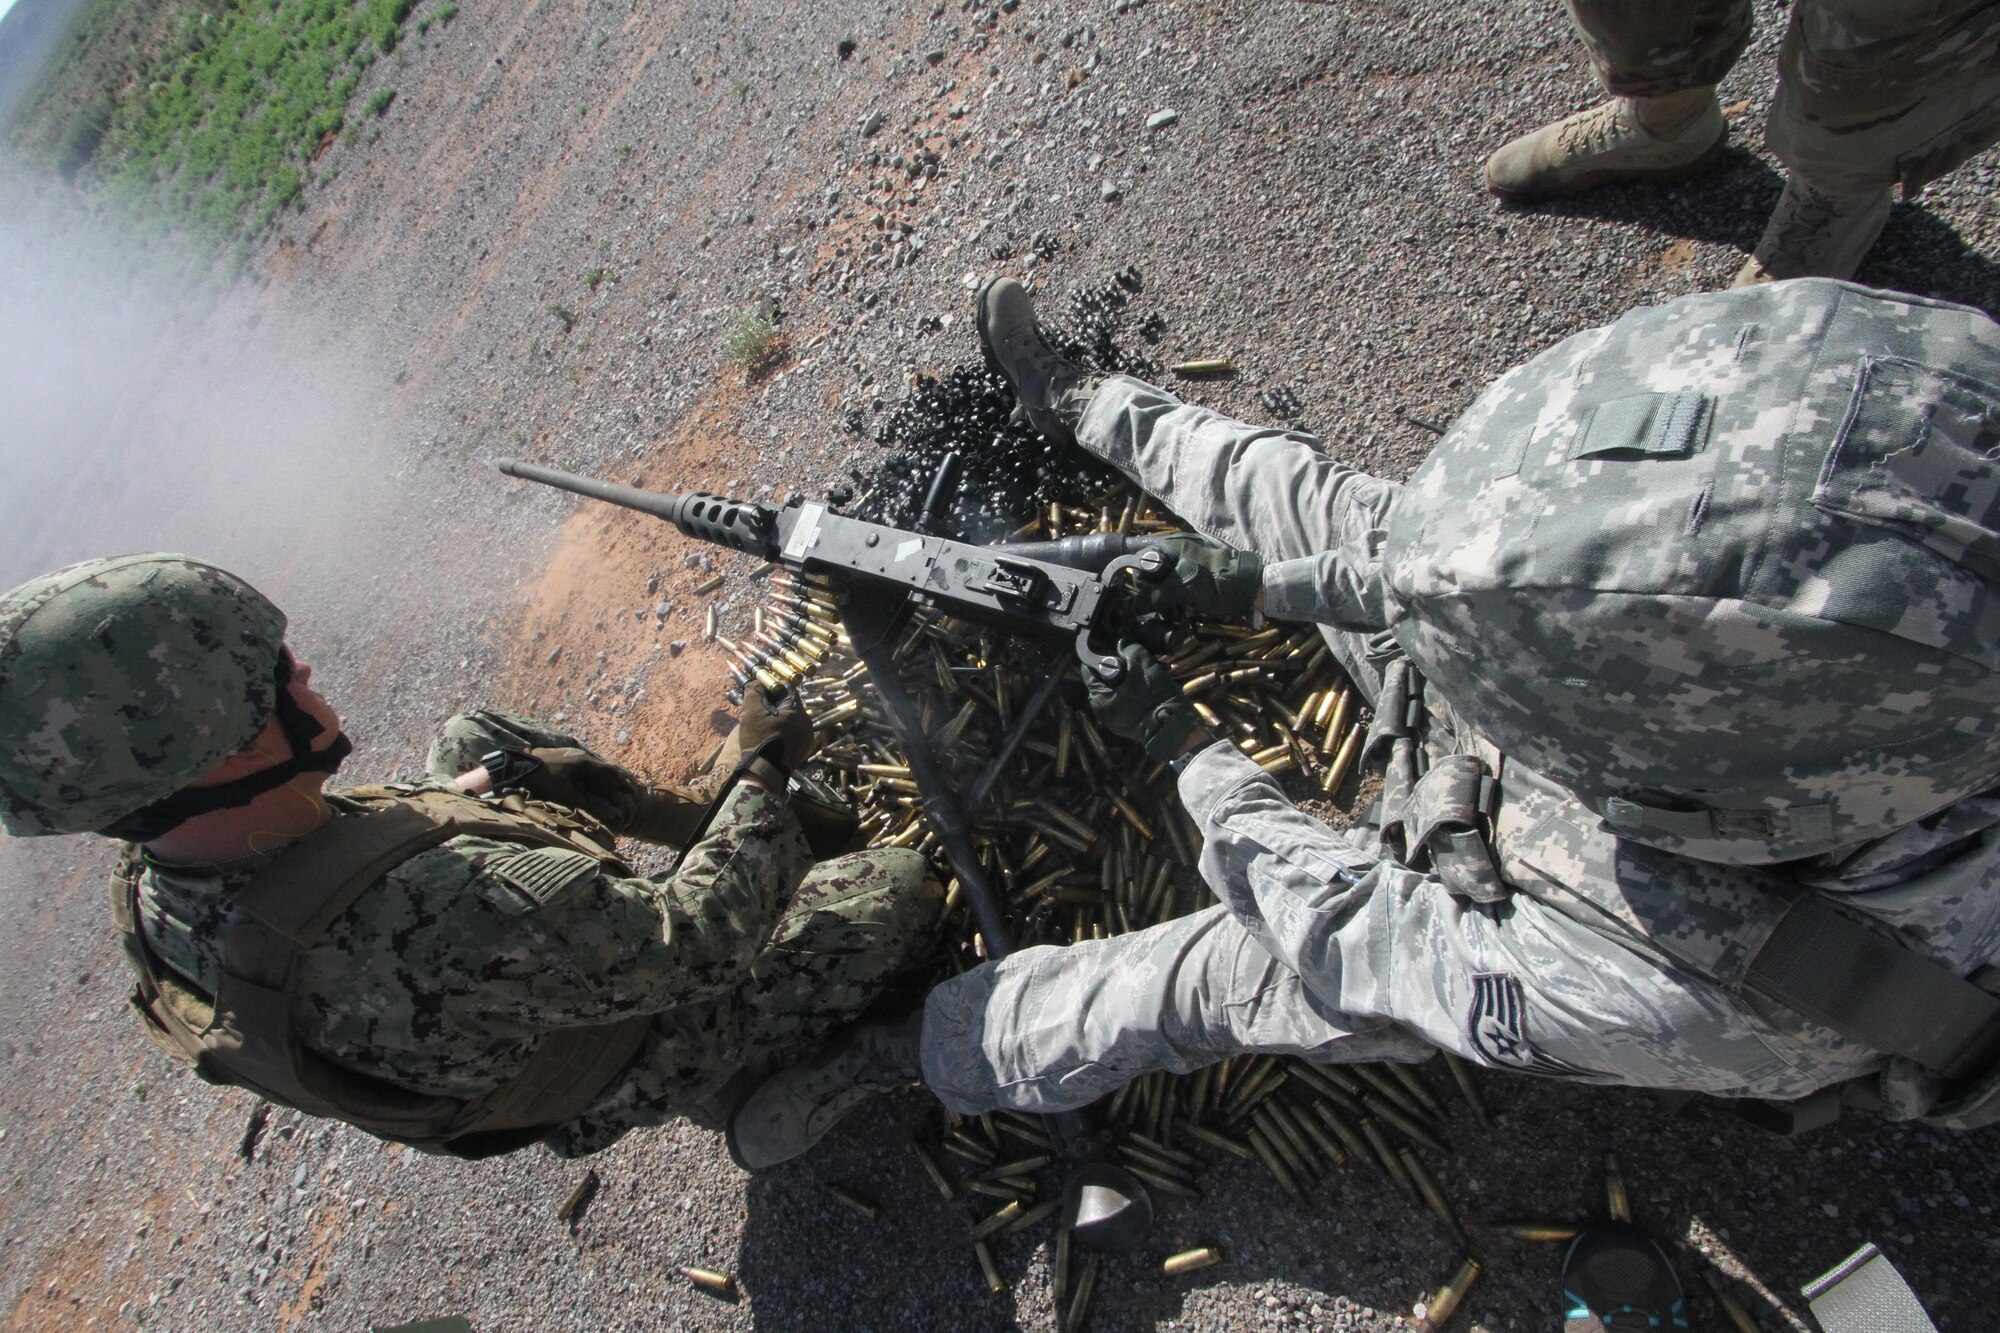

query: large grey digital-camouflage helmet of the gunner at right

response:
[1382,280,2000,865]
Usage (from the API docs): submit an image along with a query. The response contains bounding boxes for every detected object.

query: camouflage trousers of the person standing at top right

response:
[1568,0,2000,198]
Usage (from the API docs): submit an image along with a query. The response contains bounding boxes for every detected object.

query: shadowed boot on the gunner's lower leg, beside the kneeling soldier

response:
[724,1009,924,1171]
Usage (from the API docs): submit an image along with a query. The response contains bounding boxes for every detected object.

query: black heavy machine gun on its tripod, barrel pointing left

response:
[498,458,1174,1249]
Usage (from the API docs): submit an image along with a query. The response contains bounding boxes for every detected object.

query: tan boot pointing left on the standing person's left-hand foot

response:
[1486,88,1730,200]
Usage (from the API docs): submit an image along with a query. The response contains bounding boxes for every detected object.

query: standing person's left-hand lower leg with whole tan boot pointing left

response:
[1486,0,1750,200]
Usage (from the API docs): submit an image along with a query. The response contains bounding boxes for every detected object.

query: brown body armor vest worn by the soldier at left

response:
[112,787,652,1157]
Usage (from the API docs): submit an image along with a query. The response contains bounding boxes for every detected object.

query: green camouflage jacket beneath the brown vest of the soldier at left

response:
[140,772,810,1151]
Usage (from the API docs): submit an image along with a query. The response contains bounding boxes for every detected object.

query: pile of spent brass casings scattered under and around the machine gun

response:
[730,480,1486,1329]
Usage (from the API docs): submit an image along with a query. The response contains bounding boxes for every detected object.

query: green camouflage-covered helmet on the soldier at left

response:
[0,554,284,837]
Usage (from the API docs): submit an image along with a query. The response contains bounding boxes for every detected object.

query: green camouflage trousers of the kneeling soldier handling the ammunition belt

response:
[428,711,944,1157]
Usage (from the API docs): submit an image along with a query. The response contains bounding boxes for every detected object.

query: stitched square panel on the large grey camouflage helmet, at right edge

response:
[1812,356,2000,578]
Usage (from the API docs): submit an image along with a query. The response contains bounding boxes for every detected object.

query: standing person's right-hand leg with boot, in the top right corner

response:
[1736,0,2000,284]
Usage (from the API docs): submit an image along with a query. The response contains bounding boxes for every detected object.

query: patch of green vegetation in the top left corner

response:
[10,0,458,258]
